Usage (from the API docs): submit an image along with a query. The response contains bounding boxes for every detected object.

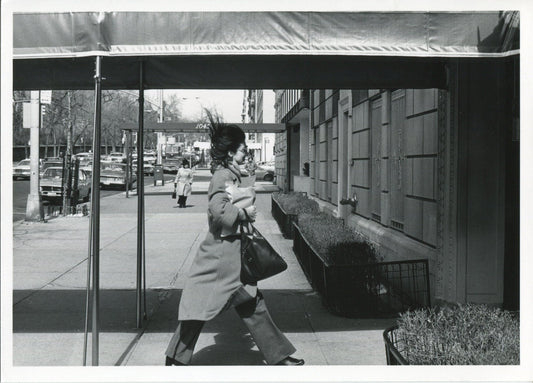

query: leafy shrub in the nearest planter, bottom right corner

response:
[386,304,520,365]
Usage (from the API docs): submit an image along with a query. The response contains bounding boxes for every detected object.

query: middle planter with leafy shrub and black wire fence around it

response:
[294,213,429,318]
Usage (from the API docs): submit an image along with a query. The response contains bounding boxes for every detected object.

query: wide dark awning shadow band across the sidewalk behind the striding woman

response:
[13,289,391,332]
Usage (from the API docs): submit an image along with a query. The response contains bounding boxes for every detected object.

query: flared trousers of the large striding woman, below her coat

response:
[166,288,296,364]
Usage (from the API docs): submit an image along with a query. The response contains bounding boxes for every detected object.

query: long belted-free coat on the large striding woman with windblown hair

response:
[178,168,257,321]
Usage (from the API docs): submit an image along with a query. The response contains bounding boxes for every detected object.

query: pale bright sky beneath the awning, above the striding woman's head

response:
[145,89,274,122]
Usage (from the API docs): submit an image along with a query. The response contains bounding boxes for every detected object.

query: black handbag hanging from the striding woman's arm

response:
[240,211,287,285]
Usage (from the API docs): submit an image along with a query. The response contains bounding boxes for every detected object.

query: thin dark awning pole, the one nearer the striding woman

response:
[137,61,144,328]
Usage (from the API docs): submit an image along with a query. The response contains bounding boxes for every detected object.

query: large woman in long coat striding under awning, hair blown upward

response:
[165,115,304,366]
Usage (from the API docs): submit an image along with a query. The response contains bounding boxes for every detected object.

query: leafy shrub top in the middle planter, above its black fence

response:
[298,213,376,265]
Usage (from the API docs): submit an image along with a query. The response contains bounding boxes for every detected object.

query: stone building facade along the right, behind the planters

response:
[275,60,519,309]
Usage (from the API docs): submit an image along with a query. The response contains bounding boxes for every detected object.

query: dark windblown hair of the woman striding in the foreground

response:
[205,110,246,173]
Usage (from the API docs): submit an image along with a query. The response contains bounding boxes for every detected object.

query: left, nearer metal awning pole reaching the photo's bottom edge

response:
[89,56,102,366]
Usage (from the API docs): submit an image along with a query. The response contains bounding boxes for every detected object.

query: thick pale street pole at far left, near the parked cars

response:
[24,91,44,221]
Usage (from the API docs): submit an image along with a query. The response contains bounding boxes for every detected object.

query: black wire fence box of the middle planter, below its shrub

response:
[294,224,429,318]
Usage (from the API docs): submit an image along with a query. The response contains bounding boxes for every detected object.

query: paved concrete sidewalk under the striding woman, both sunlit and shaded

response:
[13,194,394,366]
